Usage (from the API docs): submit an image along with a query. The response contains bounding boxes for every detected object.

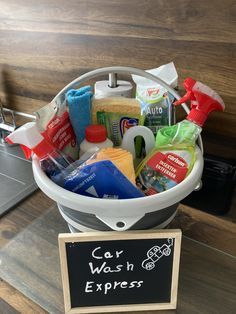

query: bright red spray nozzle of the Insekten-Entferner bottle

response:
[174,77,225,126]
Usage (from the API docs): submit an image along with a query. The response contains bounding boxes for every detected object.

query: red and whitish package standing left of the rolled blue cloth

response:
[35,97,78,160]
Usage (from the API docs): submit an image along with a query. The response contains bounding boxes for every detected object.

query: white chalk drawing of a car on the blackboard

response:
[142,239,173,270]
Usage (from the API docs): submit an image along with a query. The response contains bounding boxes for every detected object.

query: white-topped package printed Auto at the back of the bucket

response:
[132,62,178,135]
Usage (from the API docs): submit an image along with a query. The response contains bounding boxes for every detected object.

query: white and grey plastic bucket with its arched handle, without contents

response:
[32,67,203,232]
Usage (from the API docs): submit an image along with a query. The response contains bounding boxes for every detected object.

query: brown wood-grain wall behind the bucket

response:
[0,0,236,157]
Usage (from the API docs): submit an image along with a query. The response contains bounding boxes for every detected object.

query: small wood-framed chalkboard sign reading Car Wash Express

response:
[59,230,181,313]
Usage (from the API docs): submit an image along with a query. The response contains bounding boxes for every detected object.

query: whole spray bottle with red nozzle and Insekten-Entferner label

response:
[136,78,225,195]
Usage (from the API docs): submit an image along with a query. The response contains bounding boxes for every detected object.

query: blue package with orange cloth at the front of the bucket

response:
[49,148,144,199]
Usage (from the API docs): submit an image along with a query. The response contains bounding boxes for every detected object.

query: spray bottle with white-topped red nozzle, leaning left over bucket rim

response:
[6,122,73,185]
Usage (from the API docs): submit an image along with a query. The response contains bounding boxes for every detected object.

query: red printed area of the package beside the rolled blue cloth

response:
[42,111,76,150]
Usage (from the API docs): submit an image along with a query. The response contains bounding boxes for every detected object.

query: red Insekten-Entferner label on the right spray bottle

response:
[147,152,188,183]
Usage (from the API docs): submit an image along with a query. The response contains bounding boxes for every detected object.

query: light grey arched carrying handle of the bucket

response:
[52,66,203,153]
